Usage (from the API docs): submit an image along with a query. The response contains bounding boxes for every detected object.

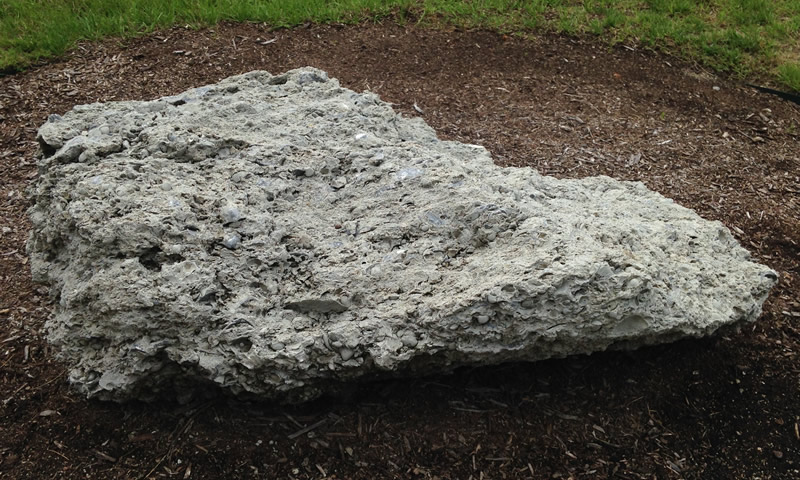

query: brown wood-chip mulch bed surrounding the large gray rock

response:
[0,24,800,479]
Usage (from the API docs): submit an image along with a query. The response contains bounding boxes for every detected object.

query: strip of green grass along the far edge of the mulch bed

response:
[0,0,800,90]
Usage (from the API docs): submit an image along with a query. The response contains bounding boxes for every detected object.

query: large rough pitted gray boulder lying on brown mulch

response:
[28,69,777,401]
